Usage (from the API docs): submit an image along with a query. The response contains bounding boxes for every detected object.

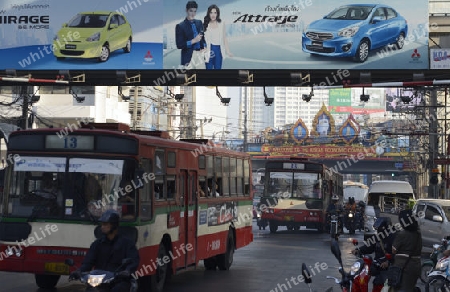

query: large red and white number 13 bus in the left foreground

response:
[0,124,253,291]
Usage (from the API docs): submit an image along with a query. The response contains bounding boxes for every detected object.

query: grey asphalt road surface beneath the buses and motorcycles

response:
[0,222,426,292]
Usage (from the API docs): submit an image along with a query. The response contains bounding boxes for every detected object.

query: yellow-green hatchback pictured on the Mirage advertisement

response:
[53,11,133,62]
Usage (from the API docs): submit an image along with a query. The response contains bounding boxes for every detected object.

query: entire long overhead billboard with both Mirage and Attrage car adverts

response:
[0,0,429,70]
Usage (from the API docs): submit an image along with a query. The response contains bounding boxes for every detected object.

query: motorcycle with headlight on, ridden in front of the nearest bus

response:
[65,259,138,292]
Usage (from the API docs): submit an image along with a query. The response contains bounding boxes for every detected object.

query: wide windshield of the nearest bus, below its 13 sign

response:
[5,156,135,221]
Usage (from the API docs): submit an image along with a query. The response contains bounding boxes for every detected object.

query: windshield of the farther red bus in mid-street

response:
[265,171,322,199]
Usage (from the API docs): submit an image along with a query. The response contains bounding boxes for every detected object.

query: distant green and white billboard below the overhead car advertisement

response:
[328,88,386,115]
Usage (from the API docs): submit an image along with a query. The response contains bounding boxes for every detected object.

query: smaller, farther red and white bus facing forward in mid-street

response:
[260,158,343,233]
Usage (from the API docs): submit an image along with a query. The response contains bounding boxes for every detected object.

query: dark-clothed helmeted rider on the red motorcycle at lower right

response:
[352,217,395,292]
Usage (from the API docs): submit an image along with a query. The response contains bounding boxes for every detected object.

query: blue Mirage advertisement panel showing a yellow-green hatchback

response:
[0,0,163,70]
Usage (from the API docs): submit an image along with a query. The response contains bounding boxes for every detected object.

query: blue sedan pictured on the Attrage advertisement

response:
[302,4,408,63]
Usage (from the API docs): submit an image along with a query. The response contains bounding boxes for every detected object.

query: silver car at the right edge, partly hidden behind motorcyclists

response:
[413,199,450,248]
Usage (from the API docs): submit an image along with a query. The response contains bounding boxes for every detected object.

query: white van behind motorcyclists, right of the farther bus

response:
[364,180,415,240]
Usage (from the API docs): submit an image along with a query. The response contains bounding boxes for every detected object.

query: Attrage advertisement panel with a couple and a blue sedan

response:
[163,0,429,69]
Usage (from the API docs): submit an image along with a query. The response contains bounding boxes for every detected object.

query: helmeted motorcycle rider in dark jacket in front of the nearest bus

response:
[69,209,139,292]
